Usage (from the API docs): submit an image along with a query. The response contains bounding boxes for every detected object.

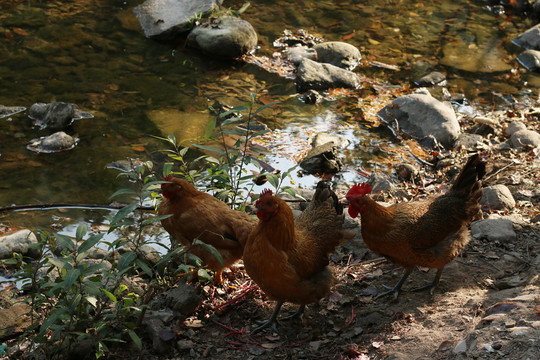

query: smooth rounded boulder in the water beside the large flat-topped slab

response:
[187,16,257,59]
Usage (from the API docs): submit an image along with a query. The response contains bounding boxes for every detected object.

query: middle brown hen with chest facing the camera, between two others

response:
[244,181,355,333]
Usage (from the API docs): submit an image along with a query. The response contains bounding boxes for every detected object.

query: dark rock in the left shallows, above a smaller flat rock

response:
[28,102,94,129]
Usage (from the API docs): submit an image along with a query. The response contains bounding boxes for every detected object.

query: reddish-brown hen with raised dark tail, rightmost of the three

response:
[347,154,486,299]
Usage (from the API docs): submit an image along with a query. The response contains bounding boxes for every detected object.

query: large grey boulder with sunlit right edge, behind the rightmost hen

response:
[377,94,460,147]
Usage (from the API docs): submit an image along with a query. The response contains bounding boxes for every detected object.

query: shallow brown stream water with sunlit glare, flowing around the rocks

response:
[0,0,540,238]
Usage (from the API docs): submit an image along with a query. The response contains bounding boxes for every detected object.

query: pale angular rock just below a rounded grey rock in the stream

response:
[296,59,360,92]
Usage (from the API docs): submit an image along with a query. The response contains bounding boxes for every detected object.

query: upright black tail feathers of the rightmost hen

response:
[450,154,486,201]
